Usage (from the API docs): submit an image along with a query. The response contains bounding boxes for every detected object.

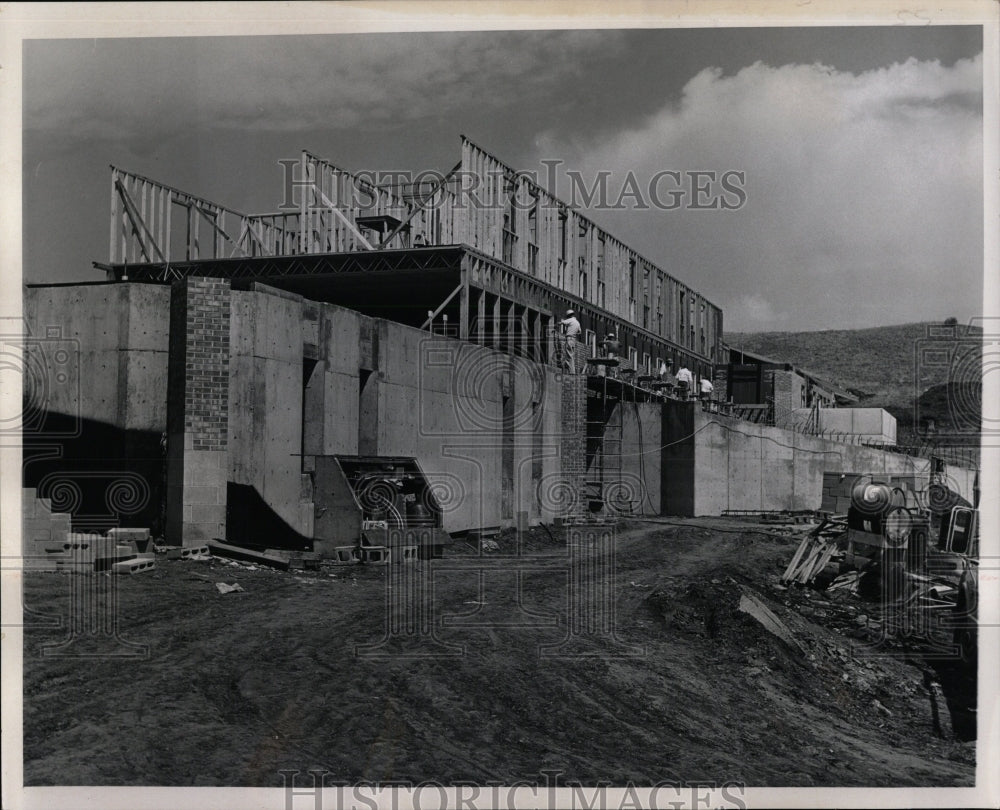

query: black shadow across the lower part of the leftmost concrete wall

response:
[22,412,166,536]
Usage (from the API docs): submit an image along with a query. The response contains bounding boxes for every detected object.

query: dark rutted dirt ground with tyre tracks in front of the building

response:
[24,519,975,786]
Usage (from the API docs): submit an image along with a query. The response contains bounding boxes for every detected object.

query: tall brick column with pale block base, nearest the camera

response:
[166,278,230,546]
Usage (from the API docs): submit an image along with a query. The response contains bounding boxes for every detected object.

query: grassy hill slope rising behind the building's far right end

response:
[725,323,982,442]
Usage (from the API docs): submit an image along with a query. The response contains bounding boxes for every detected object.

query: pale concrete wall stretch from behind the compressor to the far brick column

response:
[377,321,562,531]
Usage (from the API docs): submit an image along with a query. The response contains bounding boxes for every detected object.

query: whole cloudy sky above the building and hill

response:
[23,26,983,332]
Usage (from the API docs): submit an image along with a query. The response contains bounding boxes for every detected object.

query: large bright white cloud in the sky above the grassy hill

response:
[549,57,983,329]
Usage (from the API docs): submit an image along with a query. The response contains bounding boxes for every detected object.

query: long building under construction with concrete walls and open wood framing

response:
[25,138,976,556]
